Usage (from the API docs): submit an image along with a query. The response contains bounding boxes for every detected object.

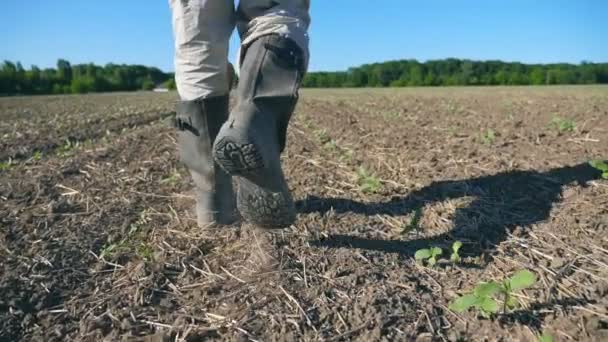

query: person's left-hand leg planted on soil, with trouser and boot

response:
[170,0,237,226]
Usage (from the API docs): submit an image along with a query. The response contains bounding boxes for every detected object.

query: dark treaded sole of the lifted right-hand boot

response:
[213,137,295,229]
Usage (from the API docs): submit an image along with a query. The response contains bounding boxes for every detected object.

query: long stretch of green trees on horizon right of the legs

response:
[303,58,608,88]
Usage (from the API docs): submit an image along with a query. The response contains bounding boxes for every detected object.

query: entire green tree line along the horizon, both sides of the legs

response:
[0,58,608,95]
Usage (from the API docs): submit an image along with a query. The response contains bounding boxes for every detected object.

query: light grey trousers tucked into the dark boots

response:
[169,0,310,101]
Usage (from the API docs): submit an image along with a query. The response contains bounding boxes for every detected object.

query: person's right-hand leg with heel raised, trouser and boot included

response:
[213,0,310,228]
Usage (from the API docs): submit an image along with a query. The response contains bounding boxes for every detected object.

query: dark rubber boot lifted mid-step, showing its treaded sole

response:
[213,35,305,228]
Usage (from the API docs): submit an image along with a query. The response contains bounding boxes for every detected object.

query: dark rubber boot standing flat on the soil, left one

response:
[175,95,238,227]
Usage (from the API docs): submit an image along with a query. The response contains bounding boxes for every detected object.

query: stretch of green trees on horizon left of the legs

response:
[0,59,175,95]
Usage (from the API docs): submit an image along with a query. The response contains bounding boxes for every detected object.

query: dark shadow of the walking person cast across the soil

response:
[296,163,601,256]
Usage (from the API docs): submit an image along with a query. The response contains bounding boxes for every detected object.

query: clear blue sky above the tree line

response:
[0,0,608,71]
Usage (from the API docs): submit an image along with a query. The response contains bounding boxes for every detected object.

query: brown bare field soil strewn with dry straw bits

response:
[0,87,608,341]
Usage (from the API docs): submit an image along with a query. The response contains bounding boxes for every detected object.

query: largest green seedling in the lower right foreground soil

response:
[450,270,536,318]
